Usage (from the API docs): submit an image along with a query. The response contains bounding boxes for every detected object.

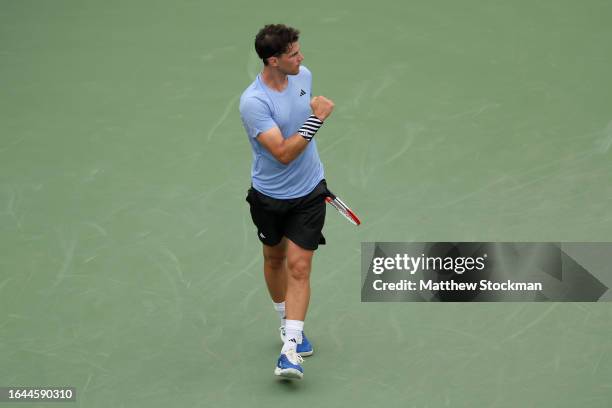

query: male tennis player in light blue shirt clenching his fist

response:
[240,24,334,378]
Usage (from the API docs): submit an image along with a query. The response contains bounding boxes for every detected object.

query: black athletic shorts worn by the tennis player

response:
[246,180,328,251]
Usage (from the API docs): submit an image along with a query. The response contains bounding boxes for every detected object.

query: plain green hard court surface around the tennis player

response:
[0,0,612,408]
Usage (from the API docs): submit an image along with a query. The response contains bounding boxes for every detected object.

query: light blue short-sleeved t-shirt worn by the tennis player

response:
[240,66,324,199]
